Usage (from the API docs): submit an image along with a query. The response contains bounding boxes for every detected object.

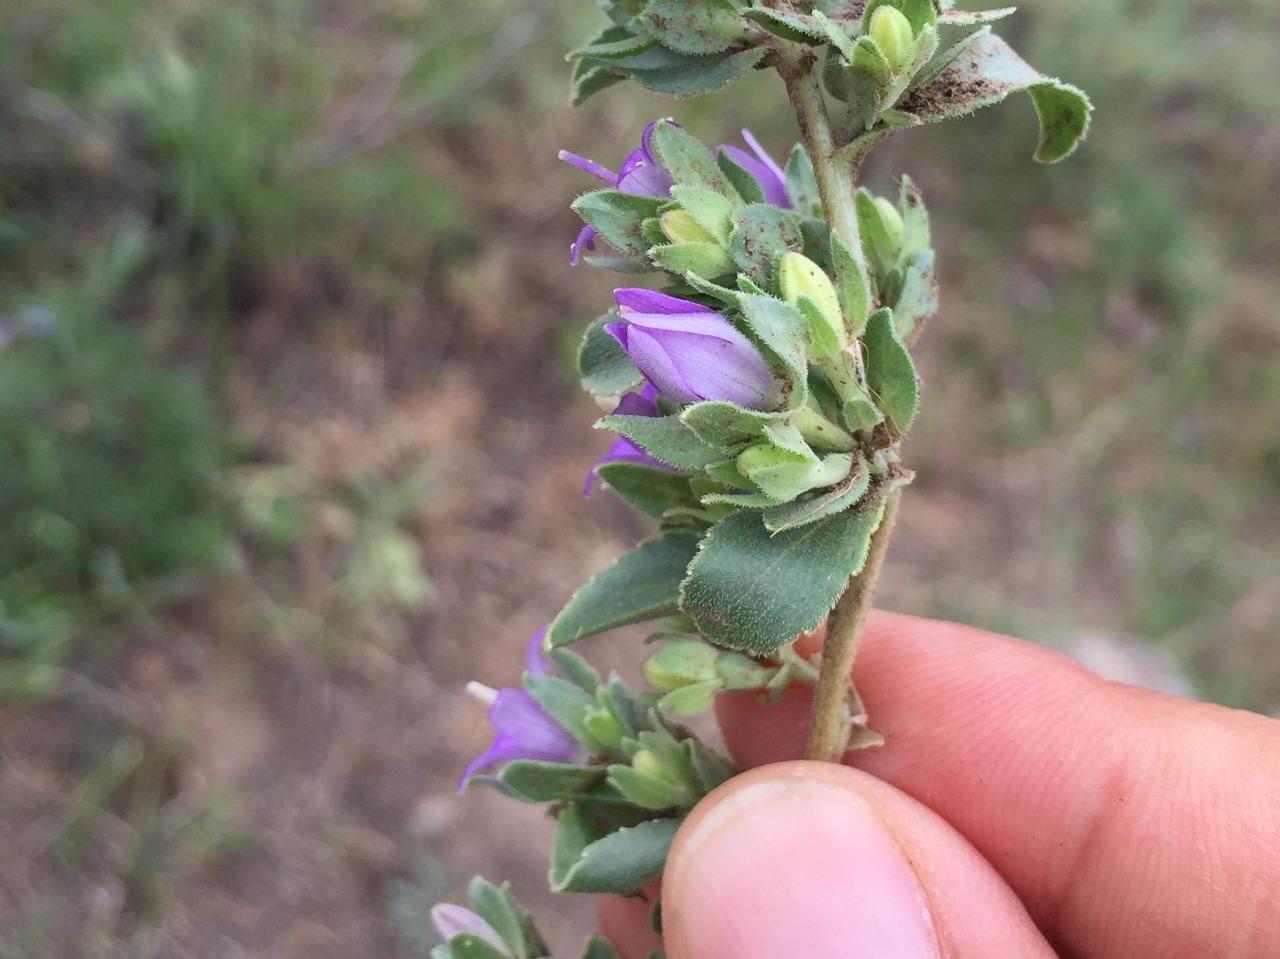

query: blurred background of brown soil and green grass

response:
[0,0,1280,959]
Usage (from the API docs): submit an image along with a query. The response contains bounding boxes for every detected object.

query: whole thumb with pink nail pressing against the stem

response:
[663,762,1053,959]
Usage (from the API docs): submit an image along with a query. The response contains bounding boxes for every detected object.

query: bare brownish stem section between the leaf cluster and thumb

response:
[809,488,902,763]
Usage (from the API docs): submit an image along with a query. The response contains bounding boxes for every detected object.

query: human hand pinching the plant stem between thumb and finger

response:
[600,613,1280,959]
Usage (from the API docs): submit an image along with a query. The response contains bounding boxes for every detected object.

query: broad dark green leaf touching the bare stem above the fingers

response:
[681,503,883,656]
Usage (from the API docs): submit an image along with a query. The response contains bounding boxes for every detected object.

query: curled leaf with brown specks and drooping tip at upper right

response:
[899,33,1093,163]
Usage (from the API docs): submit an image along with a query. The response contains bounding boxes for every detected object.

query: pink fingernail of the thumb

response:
[663,777,940,959]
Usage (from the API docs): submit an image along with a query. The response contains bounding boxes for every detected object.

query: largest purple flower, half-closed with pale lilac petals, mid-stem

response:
[604,289,778,410]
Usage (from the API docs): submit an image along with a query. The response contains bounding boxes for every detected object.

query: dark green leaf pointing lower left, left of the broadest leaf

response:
[547,534,698,648]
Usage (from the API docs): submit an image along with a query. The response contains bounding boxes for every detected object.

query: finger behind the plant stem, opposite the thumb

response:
[718,613,1280,959]
